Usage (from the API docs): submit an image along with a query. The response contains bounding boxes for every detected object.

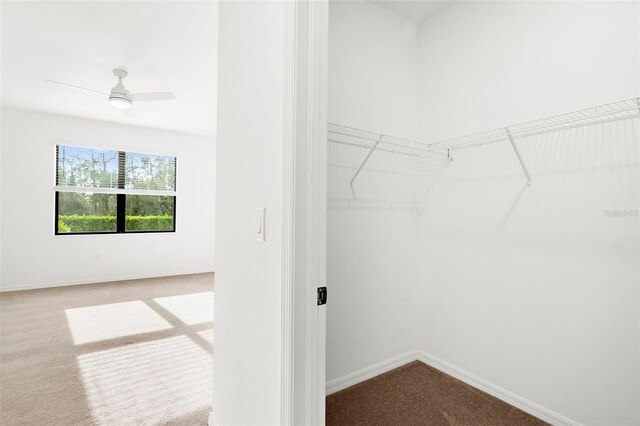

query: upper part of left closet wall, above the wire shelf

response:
[328,1,420,138]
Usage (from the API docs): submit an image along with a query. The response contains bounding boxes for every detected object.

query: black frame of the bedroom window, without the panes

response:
[53,145,178,235]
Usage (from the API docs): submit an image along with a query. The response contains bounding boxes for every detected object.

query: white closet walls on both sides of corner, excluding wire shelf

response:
[327,2,640,424]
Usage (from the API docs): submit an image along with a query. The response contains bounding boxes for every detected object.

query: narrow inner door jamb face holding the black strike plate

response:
[304,0,331,426]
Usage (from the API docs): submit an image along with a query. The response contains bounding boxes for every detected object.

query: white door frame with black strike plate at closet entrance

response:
[281,0,329,425]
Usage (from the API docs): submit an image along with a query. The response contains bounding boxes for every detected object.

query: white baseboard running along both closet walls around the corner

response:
[327,351,582,426]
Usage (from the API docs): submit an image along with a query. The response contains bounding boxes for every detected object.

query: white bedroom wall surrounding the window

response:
[0,108,215,291]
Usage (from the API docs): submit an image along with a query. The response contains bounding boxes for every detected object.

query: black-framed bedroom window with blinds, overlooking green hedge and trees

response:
[55,145,176,235]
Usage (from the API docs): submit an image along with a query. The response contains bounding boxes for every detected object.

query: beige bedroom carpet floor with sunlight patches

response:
[0,274,213,426]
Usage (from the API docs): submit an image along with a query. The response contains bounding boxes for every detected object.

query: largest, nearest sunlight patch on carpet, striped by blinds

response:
[77,336,213,425]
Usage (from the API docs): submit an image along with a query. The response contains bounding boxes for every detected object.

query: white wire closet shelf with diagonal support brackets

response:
[327,97,640,187]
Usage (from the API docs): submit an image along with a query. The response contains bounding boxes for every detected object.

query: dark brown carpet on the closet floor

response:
[326,361,547,426]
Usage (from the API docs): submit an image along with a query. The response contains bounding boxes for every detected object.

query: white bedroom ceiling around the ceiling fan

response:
[1,1,218,135]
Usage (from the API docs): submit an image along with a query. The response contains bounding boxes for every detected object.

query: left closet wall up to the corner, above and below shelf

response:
[327,2,419,382]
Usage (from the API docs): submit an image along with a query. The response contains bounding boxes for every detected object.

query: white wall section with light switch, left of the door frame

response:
[213,2,285,426]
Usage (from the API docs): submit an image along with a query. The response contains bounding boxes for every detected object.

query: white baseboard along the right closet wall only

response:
[417,351,581,426]
